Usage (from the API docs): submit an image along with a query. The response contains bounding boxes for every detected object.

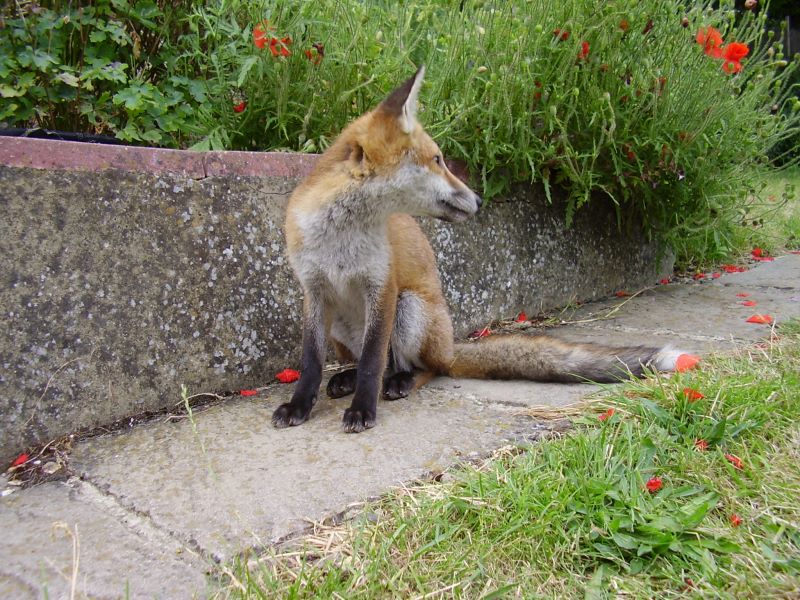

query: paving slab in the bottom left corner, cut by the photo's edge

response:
[0,480,209,600]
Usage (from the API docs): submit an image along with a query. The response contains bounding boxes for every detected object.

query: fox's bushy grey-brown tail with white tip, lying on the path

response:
[448,334,682,383]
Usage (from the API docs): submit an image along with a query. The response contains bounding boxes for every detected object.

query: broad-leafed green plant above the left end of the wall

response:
[0,0,200,145]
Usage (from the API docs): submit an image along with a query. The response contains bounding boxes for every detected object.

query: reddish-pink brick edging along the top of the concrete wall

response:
[0,136,319,179]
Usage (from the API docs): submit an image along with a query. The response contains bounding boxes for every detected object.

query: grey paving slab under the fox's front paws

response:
[71,384,535,560]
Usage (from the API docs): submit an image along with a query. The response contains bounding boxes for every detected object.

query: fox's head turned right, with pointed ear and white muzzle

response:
[342,67,481,221]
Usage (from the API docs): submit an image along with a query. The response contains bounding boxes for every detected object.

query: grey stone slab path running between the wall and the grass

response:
[0,255,800,599]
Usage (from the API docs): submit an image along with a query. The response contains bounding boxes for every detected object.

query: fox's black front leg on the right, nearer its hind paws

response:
[342,285,397,433]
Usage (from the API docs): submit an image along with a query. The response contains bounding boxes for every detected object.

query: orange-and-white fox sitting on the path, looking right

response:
[272,65,682,433]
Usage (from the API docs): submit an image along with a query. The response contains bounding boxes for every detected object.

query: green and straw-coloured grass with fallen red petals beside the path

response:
[212,321,800,598]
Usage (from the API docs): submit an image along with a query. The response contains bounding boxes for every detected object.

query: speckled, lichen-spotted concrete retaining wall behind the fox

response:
[0,138,670,461]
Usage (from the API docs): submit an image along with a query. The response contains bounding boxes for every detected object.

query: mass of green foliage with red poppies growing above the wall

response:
[0,0,800,260]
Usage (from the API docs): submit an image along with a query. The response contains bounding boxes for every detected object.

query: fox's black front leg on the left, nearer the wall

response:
[272,291,325,428]
